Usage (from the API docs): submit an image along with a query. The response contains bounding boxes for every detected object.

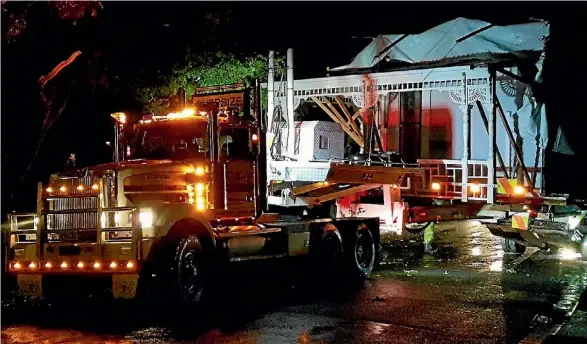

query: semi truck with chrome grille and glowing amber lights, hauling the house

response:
[8,81,392,304]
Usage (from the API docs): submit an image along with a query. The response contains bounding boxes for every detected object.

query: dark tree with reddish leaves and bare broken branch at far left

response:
[1,1,106,211]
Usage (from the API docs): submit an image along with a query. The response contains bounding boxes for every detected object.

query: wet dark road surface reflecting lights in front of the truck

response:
[2,221,587,344]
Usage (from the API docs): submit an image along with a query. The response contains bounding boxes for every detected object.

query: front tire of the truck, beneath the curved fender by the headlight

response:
[173,235,207,305]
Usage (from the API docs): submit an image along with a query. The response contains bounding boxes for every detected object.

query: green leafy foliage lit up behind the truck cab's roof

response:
[133,51,281,113]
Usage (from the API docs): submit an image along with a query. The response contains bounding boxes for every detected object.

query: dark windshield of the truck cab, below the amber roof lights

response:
[131,123,209,160]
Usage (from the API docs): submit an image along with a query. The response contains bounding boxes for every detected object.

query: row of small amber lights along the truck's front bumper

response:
[9,260,137,272]
